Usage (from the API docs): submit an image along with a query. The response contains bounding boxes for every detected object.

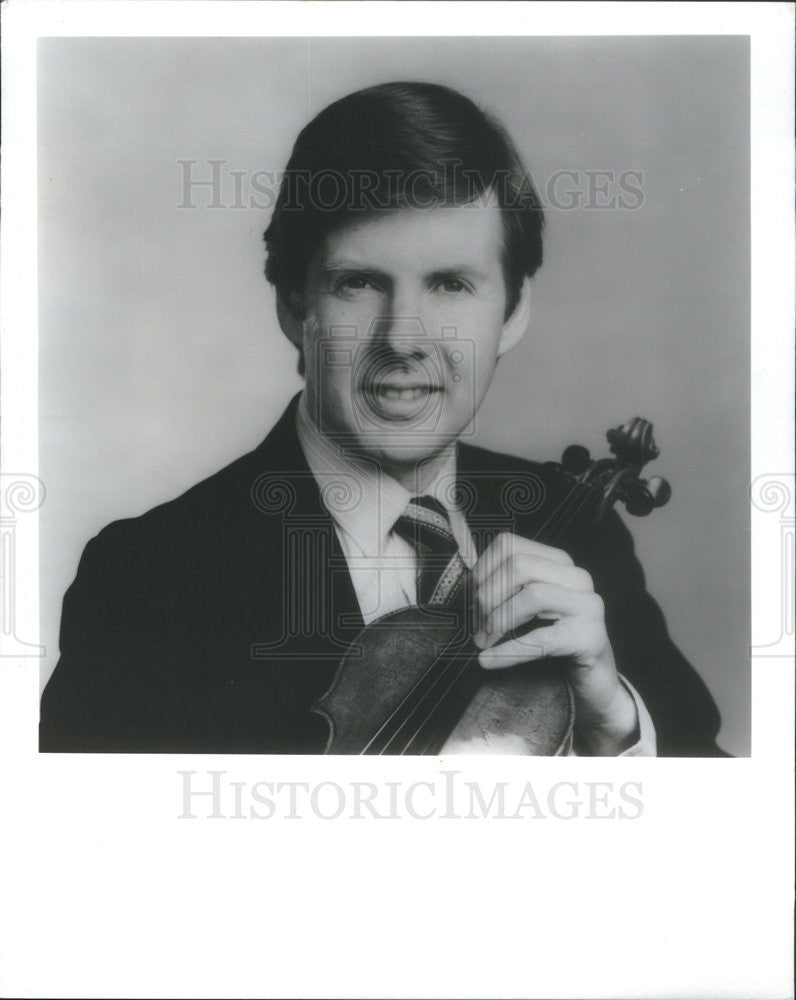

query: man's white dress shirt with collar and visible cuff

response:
[296,395,656,757]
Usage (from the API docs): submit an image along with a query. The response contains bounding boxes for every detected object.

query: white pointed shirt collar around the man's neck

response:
[296,393,456,556]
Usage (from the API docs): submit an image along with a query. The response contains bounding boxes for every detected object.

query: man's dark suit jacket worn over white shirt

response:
[40,400,721,756]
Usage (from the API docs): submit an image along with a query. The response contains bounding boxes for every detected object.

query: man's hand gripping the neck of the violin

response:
[473,533,638,756]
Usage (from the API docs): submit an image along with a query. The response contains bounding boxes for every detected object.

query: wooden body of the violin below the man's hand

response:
[314,607,575,756]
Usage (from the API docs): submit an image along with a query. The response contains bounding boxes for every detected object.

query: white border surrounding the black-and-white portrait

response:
[0,0,794,998]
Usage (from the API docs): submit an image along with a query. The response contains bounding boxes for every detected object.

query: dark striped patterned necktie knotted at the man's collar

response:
[393,496,467,608]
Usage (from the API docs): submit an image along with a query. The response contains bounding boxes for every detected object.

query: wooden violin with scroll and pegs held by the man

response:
[313,417,671,756]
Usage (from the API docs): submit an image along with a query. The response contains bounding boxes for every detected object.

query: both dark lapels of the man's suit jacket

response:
[219,397,552,724]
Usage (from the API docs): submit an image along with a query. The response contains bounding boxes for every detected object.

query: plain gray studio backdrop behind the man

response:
[39,37,750,754]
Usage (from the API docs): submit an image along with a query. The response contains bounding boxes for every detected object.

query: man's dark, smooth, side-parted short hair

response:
[265,83,544,317]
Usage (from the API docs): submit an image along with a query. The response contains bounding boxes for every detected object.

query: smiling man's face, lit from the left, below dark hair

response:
[293,204,527,485]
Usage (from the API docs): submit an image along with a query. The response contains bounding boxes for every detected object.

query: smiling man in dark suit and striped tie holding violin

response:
[41,83,721,756]
